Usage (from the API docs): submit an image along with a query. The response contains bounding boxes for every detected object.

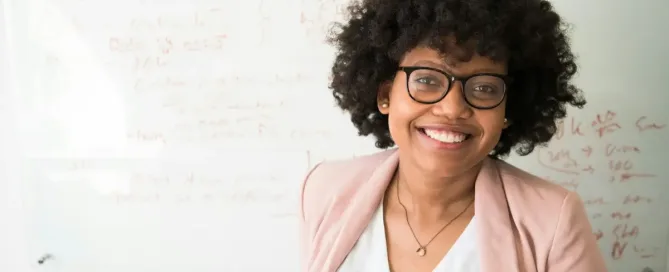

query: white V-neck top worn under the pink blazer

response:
[337,198,480,272]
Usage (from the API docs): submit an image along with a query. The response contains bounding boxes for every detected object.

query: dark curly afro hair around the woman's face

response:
[328,0,586,159]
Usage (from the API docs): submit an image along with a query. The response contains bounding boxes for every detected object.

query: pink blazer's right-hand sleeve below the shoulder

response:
[546,192,608,272]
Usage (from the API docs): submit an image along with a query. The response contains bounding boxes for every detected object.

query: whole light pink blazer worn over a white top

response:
[300,149,607,272]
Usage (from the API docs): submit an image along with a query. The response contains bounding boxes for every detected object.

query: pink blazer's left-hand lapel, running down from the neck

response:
[319,150,399,272]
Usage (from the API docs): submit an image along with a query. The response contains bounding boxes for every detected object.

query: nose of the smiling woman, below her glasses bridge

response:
[432,81,473,120]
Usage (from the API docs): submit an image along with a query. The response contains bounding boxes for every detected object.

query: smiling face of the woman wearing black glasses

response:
[378,47,507,177]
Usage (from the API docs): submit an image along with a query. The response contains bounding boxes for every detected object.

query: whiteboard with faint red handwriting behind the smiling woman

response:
[6,0,669,272]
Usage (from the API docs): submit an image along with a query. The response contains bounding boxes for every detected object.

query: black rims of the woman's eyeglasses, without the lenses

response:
[397,66,513,110]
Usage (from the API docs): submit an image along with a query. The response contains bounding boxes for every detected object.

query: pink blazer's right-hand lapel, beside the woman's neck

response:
[474,158,521,272]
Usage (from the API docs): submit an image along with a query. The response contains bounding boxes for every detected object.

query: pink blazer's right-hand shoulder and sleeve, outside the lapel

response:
[496,161,604,271]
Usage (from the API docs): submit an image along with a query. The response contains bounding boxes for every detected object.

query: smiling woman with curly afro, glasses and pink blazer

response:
[300,0,606,272]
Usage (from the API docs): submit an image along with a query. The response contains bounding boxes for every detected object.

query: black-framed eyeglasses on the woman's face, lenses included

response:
[399,66,511,110]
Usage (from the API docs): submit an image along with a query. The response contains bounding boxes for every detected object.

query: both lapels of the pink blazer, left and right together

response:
[322,149,520,272]
